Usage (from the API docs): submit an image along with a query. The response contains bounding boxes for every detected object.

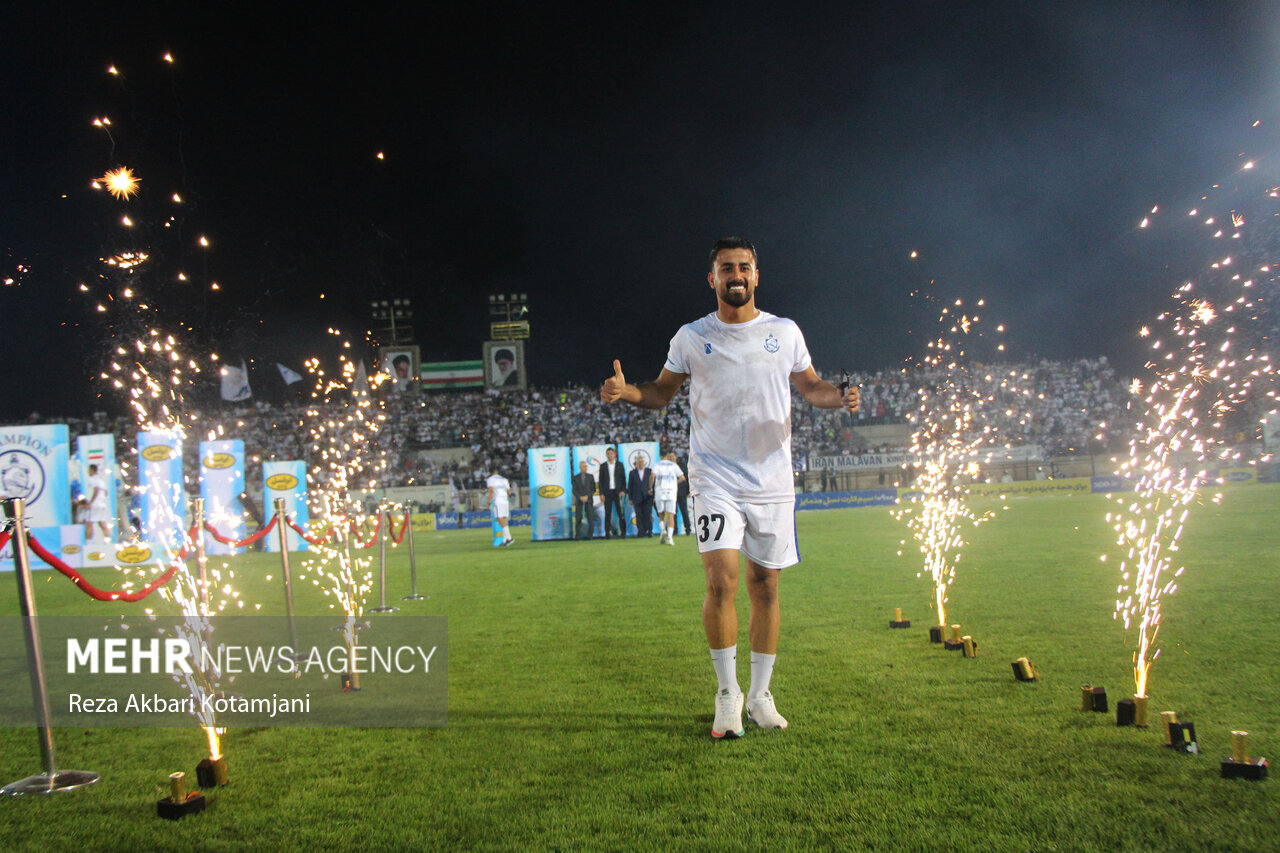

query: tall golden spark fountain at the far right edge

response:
[1102,156,1275,702]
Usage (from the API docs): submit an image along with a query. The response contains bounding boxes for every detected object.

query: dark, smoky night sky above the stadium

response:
[0,3,1280,419]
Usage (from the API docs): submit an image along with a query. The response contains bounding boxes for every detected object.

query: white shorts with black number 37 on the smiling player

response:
[692,494,800,569]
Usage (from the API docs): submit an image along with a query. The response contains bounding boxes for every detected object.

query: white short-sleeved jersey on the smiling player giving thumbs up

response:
[666,311,813,503]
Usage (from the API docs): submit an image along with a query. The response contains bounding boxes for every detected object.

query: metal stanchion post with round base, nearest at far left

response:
[0,498,99,797]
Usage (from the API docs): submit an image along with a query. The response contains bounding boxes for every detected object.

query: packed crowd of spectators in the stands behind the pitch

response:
[15,357,1128,489]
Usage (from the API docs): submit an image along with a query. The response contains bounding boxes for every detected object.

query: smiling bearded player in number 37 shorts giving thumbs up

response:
[600,237,859,738]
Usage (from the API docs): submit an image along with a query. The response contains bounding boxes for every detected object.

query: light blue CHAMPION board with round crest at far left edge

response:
[0,424,72,528]
